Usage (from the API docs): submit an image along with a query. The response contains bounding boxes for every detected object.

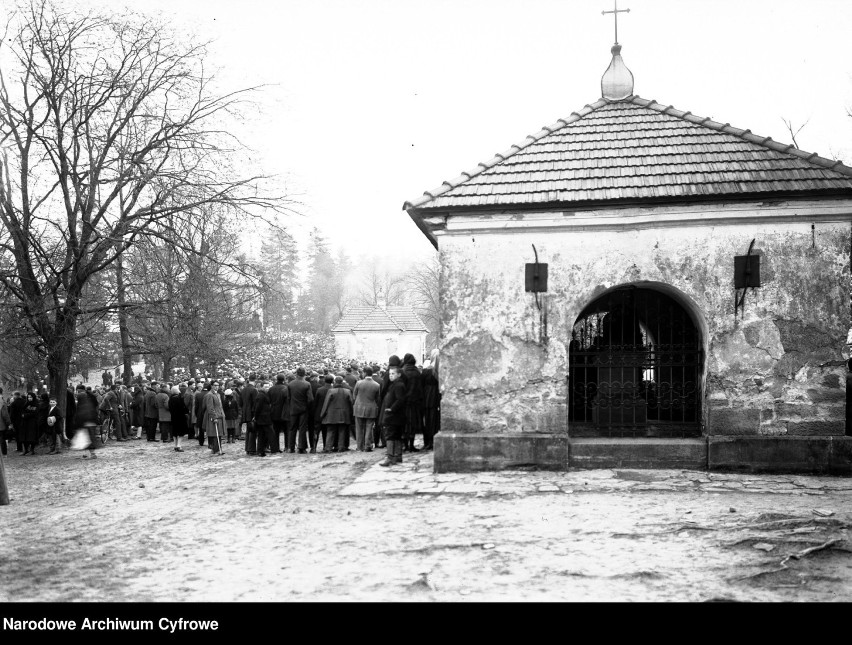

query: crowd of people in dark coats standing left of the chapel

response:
[0,350,440,466]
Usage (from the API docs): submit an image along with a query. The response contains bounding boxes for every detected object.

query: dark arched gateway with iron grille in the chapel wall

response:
[568,285,704,437]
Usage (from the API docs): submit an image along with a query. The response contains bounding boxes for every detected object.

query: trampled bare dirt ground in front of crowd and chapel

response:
[0,440,852,602]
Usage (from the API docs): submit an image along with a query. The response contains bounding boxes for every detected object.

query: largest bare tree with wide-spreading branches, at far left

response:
[0,0,285,406]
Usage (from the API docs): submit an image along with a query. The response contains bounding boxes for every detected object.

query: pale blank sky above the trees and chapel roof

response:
[13,0,852,263]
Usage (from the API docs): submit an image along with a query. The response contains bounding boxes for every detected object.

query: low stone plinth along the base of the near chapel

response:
[434,433,852,475]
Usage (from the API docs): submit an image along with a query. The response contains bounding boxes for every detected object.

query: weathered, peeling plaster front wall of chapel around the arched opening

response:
[439,221,850,435]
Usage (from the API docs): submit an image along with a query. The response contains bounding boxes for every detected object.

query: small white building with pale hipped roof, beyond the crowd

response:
[331,305,429,363]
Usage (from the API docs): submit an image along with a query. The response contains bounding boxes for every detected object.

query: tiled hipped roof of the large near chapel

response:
[403,96,852,214]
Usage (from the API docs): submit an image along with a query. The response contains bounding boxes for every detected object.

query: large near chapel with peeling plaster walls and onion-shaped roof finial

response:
[404,44,852,474]
